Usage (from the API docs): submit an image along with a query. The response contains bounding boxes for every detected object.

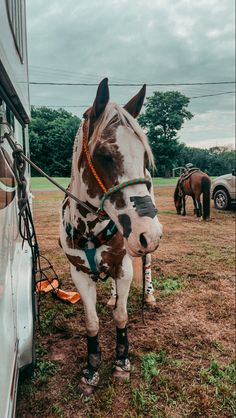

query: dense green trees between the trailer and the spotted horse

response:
[29,107,80,177]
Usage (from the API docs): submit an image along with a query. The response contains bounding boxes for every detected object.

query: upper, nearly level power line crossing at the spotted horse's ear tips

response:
[29,81,235,87]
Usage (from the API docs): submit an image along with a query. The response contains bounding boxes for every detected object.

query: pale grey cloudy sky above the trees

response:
[27,0,235,147]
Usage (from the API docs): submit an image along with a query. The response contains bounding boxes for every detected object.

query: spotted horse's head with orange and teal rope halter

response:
[79,79,162,256]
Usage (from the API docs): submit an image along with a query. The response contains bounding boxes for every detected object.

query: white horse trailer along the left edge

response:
[0,0,35,418]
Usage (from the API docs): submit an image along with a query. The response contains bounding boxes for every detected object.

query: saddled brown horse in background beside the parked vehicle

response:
[174,170,211,220]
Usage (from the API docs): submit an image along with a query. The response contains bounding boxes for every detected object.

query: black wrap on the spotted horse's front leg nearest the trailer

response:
[83,335,101,386]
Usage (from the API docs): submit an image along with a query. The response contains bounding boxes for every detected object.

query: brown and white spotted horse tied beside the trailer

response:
[60,78,162,391]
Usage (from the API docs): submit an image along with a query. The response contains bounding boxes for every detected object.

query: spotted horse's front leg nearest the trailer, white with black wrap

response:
[71,265,101,394]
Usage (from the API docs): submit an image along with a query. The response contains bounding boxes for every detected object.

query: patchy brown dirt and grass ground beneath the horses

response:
[17,187,235,418]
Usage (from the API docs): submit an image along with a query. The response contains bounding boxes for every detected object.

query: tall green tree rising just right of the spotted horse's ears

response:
[139,91,193,177]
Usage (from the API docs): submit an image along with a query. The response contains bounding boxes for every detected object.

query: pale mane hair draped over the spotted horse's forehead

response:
[89,102,155,169]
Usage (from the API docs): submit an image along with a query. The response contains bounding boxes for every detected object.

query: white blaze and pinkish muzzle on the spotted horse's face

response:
[105,122,162,256]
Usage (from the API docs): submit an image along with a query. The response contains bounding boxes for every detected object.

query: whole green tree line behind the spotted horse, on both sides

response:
[29,91,235,177]
